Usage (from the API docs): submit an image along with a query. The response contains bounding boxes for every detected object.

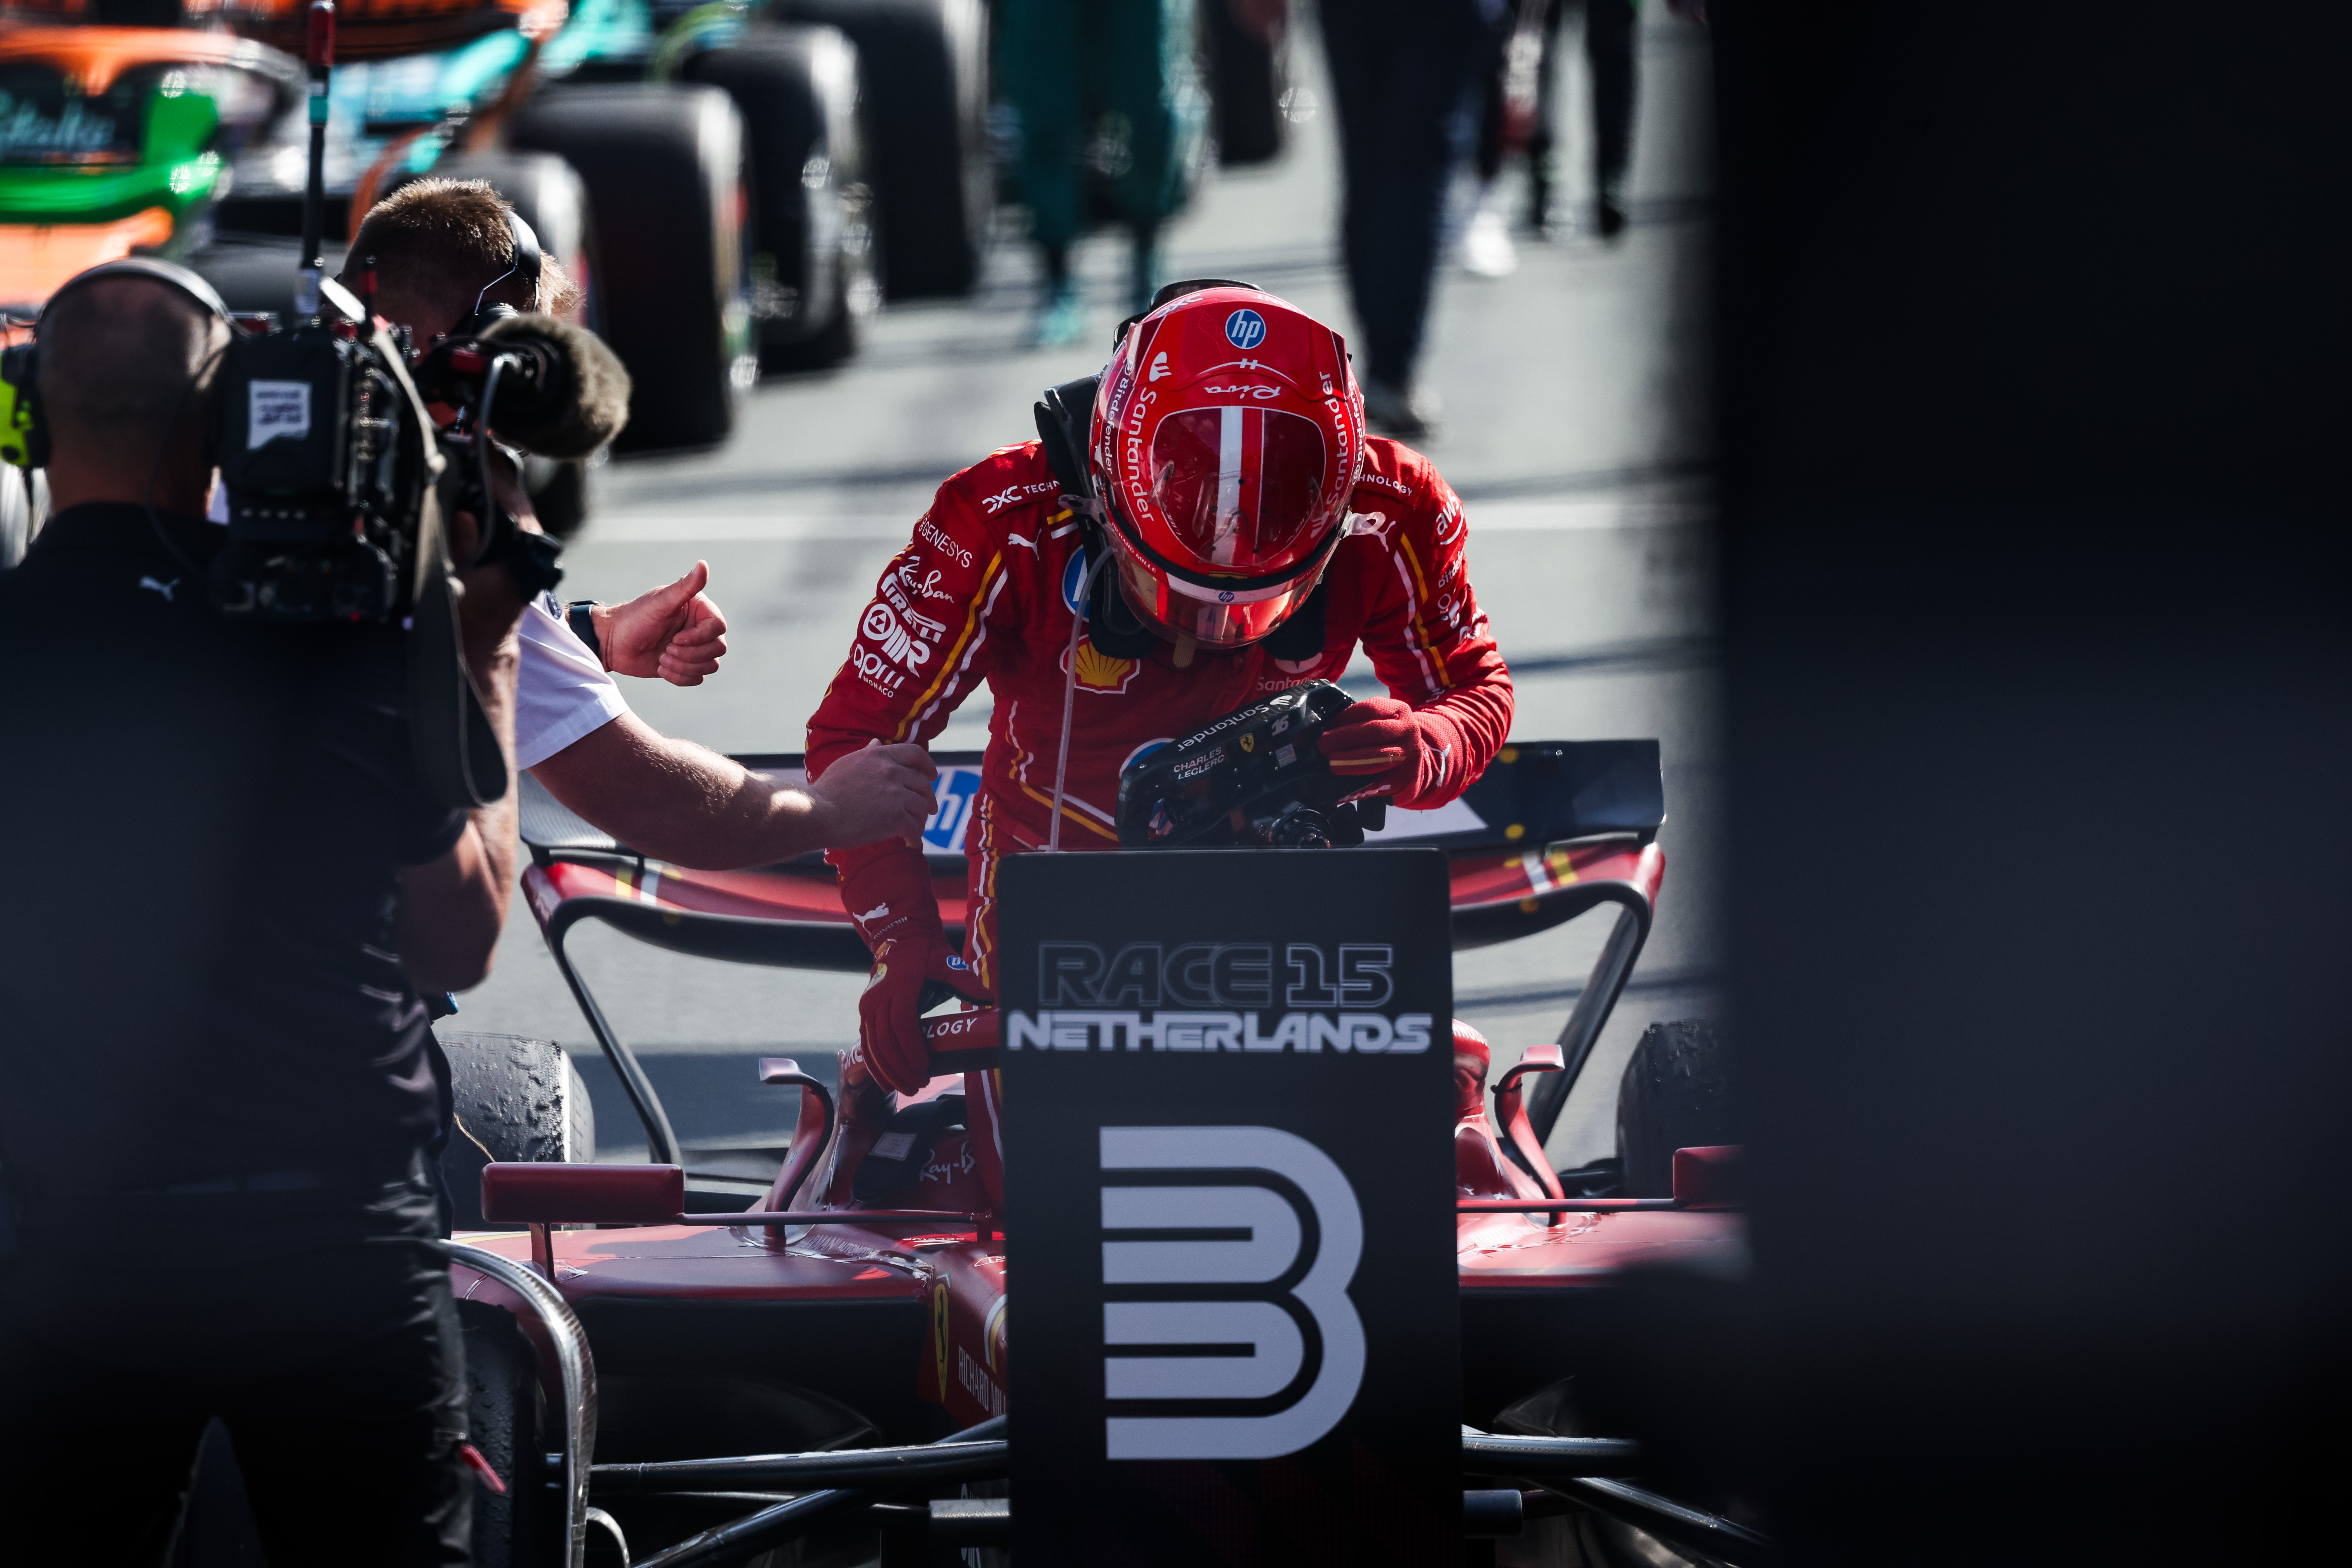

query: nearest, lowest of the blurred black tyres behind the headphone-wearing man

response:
[510,82,760,451]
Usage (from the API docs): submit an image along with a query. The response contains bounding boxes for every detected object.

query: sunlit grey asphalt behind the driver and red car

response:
[442,7,1719,1175]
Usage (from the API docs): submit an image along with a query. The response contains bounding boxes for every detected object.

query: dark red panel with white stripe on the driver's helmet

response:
[1152,407,1324,576]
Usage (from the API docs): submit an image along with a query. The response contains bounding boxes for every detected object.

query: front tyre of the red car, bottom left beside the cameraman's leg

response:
[456,1302,564,1568]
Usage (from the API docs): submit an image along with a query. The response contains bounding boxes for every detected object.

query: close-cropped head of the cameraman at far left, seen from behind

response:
[40,277,228,510]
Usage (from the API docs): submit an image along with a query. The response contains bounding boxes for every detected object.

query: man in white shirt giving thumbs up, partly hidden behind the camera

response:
[343,178,936,870]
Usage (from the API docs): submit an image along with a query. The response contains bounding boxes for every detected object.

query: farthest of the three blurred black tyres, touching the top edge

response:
[771,0,995,299]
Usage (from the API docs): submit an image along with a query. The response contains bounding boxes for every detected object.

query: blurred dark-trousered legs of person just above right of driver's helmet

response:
[1317,0,1510,440]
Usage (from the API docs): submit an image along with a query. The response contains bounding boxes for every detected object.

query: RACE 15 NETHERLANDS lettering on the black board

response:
[1004,940,1432,1056]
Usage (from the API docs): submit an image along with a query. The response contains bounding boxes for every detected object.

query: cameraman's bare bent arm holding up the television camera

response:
[398,566,522,997]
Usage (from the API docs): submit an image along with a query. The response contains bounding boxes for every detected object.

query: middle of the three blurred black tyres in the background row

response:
[680,26,877,369]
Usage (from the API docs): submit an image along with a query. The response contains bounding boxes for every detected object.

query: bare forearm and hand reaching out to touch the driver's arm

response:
[531,712,938,870]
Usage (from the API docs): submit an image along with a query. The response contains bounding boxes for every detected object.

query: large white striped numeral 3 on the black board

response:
[1101,1126,1364,1460]
